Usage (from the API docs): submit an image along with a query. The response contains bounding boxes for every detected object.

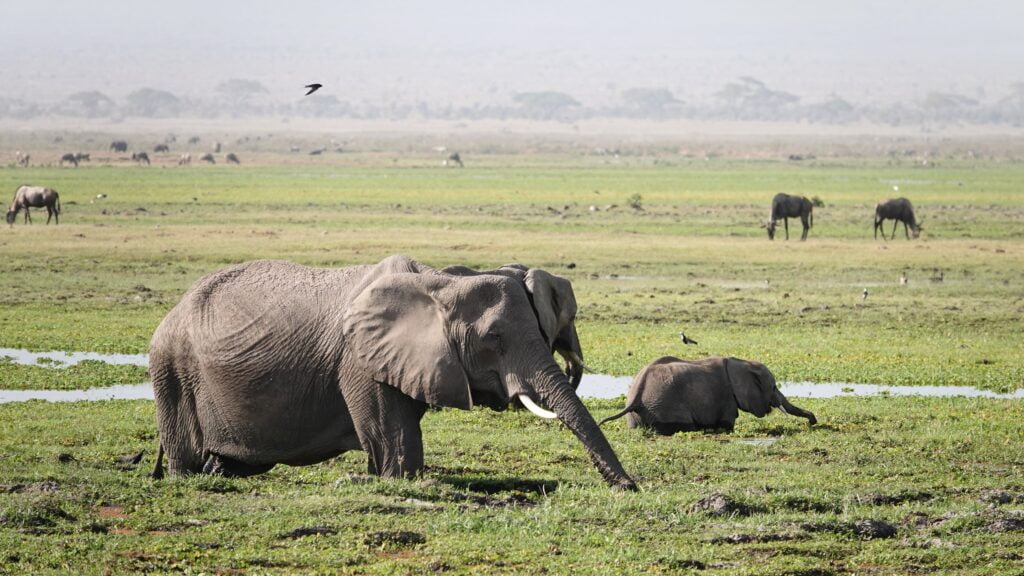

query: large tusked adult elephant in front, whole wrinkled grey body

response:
[150,256,636,489]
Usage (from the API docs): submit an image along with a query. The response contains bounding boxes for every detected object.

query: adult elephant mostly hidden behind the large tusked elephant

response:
[441,263,584,390]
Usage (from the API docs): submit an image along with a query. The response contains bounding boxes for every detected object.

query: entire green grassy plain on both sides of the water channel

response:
[0,150,1024,574]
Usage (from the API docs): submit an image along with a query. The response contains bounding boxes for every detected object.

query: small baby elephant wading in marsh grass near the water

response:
[600,356,817,436]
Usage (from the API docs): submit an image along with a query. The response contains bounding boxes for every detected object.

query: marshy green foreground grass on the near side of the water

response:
[0,398,1024,574]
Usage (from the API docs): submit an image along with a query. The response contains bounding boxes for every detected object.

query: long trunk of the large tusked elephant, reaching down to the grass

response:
[534,365,637,490]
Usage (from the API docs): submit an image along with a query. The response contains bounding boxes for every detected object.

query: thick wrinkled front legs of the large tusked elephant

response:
[342,381,427,478]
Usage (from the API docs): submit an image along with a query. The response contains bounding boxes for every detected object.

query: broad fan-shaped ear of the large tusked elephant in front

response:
[344,274,473,410]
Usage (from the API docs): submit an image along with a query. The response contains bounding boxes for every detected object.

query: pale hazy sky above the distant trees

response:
[0,0,1024,101]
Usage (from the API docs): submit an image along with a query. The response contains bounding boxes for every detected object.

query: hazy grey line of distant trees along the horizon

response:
[0,77,1024,126]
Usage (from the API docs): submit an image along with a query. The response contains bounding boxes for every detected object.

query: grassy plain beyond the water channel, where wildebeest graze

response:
[0,155,1024,390]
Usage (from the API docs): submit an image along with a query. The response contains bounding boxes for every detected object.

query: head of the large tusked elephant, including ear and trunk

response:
[344,272,635,488]
